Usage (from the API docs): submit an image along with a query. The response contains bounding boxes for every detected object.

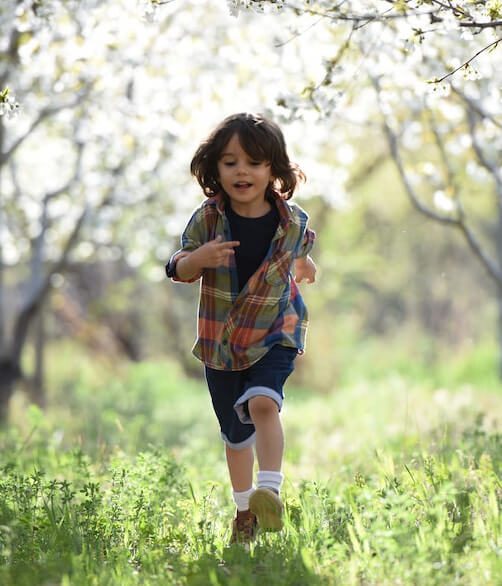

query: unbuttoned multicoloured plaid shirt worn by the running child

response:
[171,193,315,370]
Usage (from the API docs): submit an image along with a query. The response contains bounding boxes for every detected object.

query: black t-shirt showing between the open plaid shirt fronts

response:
[225,203,279,291]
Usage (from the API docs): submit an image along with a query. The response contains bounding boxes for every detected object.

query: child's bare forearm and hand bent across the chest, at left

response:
[171,236,240,282]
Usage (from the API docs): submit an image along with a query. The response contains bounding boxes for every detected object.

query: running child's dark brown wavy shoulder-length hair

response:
[190,113,305,199]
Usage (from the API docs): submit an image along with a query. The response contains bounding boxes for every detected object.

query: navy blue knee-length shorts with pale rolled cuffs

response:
[206,345,298,450]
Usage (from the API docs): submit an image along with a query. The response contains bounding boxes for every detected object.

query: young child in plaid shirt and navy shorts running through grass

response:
[166,114,316,542]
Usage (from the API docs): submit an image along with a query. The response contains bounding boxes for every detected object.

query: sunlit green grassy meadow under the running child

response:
[0,346,502,586]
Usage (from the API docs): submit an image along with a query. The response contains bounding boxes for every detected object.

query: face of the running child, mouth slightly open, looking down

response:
[218,134,273,216]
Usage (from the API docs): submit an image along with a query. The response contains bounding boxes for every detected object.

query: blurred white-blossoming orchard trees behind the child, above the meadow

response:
[0,0,502,417]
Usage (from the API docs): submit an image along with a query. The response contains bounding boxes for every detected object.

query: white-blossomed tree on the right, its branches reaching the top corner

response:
[229,0,502,375]
